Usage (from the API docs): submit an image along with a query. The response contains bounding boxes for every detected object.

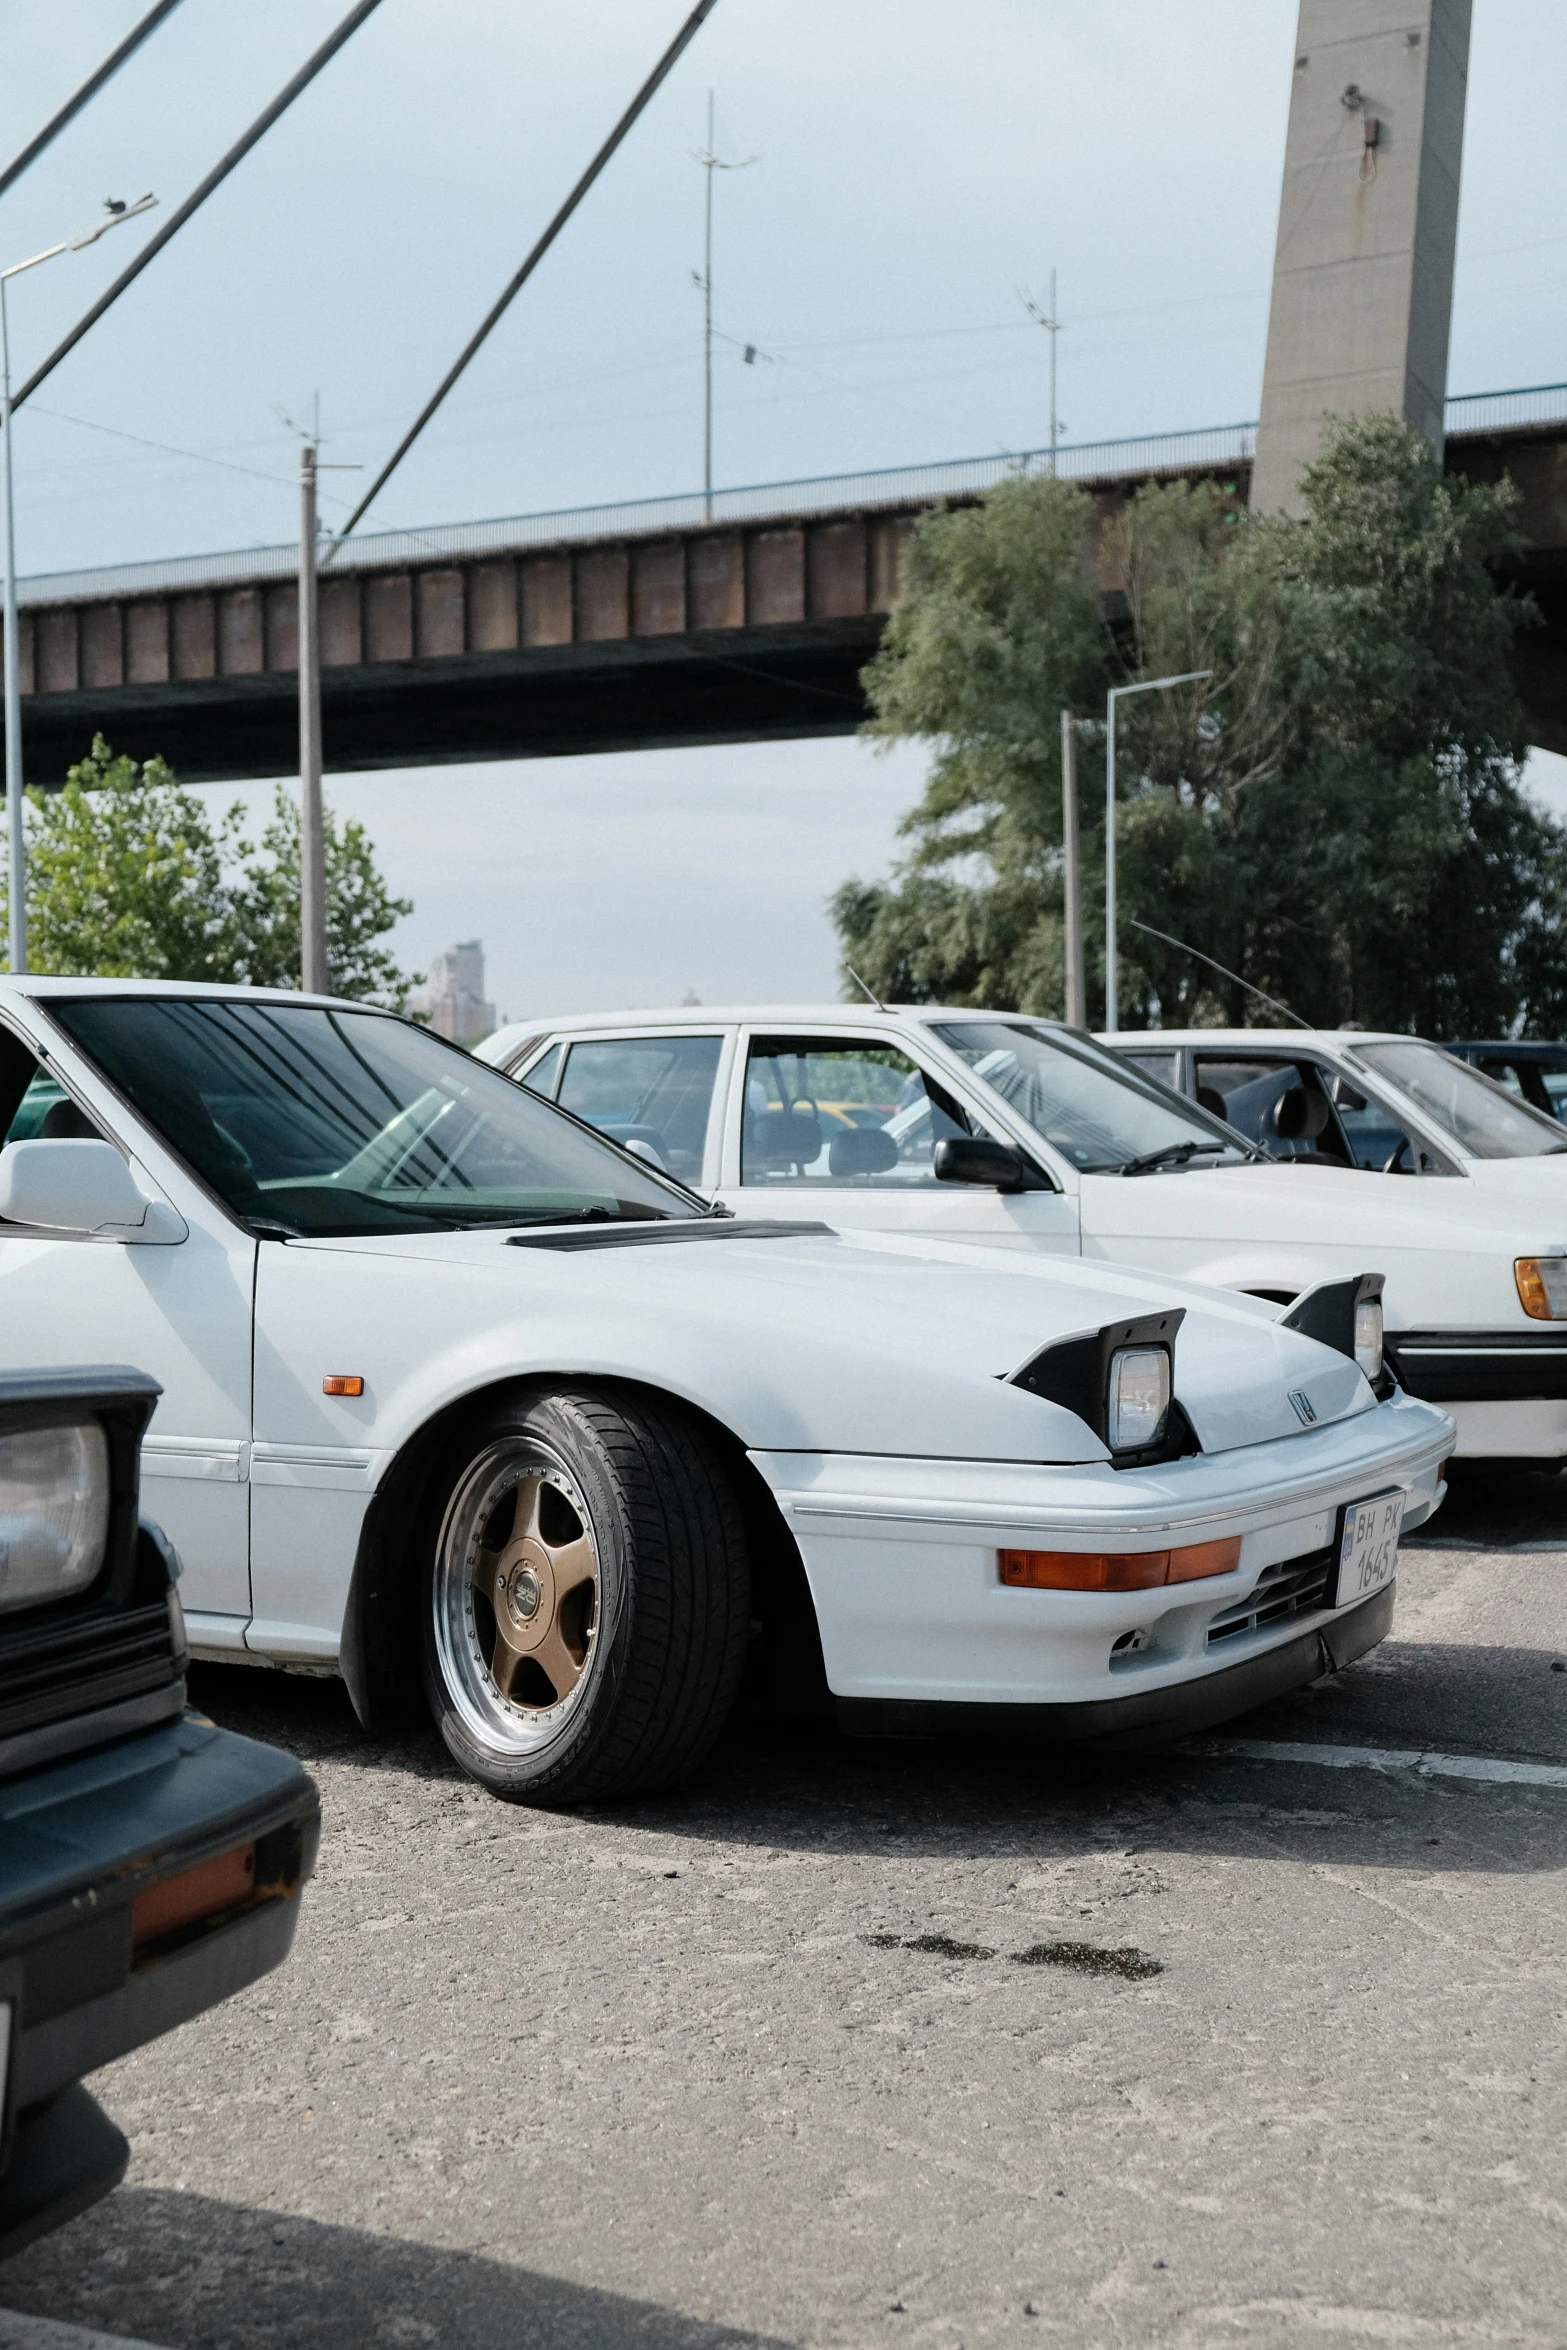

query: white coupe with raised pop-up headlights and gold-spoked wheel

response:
[0,978,1452,1802]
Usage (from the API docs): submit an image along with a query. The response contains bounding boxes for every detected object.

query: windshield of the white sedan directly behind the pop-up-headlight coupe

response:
[935,1020,1245,1175]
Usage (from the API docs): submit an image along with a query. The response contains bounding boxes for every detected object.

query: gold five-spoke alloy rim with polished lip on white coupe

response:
[435,1441,599,1751]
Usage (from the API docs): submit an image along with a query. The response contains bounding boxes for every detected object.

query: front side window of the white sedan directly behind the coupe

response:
[740,1036,982,1191]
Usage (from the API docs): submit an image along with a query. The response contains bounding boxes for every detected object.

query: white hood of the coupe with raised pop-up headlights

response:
[293,1231,1374,1462]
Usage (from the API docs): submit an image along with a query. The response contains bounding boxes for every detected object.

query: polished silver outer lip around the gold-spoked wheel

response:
[432,1436,604,1760]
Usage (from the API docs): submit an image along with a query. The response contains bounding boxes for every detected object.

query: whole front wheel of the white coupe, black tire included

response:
[421,1387,752,1805]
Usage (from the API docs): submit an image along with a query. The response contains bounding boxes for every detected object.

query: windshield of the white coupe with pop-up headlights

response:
[49,996,700,1236]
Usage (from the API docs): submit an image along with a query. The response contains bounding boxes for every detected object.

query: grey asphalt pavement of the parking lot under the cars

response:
[0,1478,1567,2350]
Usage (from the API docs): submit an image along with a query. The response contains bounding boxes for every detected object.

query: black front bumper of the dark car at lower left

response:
[0,1713,322,2258]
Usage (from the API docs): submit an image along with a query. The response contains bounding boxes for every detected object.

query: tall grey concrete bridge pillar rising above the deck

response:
[1252,0,1471,512]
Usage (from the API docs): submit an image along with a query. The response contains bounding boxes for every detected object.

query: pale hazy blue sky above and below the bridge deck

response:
[0,0,1567,1013]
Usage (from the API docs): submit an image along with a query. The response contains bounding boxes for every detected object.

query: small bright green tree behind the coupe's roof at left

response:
[0,736,413,1006]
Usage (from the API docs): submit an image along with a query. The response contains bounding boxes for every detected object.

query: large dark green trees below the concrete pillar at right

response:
[832,416,1567,1034]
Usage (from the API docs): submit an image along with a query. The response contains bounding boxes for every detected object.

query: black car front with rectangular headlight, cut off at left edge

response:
[0,1370,320,2258]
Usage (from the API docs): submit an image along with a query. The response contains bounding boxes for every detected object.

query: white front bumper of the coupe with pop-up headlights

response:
[754,1396,1452,1734]
